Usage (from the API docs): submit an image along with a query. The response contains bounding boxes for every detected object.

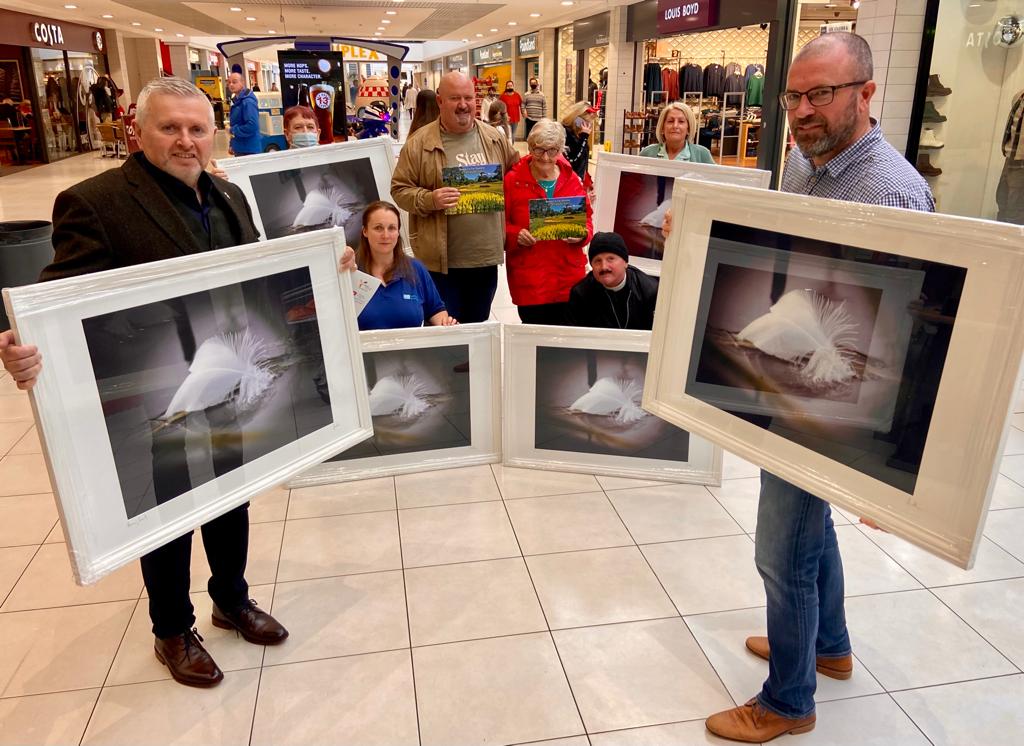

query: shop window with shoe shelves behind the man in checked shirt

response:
[909,0,1024,224]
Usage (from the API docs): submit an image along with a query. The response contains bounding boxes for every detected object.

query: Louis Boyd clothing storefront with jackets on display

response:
[616,0,790,169]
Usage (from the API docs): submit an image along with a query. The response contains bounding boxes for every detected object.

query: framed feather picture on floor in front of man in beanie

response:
[504,324,722,484]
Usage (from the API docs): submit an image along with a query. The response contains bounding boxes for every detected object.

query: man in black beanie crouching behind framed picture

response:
[567,232,657,330]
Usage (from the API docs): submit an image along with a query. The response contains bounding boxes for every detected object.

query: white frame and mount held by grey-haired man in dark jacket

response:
[3,228,373,585]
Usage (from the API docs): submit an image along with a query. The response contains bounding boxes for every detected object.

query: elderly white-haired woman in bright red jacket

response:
[505,119,594,324]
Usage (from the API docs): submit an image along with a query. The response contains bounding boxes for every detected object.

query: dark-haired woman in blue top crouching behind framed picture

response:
[355,200,459,332]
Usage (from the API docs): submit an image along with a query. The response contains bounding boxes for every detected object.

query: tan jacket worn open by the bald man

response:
[391,120,519,273]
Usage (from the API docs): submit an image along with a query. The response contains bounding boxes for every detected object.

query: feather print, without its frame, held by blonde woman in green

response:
[612,171,673,261]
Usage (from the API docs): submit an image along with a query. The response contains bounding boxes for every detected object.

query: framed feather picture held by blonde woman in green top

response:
[594,152,771,274]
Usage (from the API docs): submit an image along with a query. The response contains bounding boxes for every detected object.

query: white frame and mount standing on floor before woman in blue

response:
[288,321,502,489]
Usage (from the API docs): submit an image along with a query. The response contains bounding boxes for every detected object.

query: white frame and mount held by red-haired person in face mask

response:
[217,135,411,253]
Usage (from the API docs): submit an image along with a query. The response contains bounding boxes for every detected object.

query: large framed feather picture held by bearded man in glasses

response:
[643,179,1024,568]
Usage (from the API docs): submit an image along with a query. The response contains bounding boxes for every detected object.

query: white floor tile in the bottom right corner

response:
[893,674,1024,746]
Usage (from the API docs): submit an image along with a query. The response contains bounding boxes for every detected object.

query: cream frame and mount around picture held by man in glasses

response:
[643,179,1024,568]
